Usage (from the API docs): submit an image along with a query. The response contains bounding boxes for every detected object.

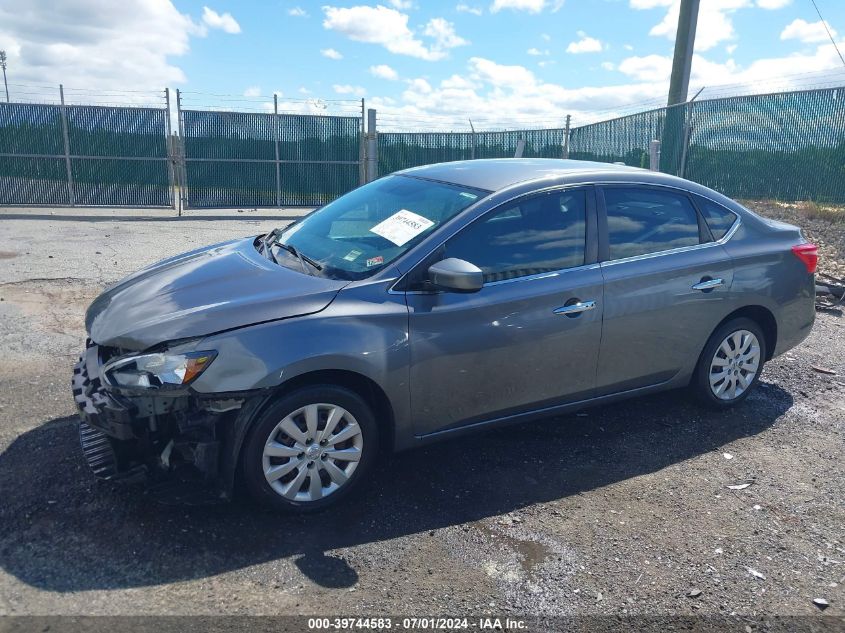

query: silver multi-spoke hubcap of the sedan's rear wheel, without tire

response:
[710,330,760,400]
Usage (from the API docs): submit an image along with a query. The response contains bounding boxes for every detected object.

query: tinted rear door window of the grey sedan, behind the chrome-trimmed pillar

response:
[604,187,699,259]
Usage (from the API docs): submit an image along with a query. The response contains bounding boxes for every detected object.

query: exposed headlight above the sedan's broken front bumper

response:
[103,351,217,389]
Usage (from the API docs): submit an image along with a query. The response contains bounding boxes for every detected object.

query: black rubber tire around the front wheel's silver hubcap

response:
[241,385,379,513]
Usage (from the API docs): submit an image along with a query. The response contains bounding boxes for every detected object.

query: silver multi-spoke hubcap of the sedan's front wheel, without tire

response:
[262,403,364,502]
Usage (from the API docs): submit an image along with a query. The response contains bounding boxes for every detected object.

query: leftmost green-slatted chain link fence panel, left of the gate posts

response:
[0,103,172,207]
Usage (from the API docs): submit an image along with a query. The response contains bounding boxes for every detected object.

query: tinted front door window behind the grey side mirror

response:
[444,189,587,282]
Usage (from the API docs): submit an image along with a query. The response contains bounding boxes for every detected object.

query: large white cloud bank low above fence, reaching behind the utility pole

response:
[367,33,845,130]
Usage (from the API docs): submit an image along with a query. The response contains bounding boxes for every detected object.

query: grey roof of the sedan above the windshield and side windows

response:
[396,158,680,191]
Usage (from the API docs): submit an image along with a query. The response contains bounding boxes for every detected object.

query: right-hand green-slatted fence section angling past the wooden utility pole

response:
[570,88,845,202]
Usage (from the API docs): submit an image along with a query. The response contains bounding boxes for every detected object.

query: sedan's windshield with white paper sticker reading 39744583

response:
[268,176,487,281]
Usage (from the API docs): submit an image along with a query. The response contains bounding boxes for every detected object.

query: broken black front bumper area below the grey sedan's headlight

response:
[72,341,259,501]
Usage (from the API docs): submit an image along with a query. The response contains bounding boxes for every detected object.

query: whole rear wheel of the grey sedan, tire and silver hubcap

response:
[691,318,766,409]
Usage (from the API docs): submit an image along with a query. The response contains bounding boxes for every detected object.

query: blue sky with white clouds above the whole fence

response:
[0,0,845,130]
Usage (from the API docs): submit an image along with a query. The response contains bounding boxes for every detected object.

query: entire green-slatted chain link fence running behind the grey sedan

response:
[0,82,845,211]
